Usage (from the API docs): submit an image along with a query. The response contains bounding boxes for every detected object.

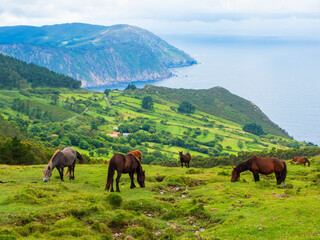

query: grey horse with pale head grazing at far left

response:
[43,147,84,182]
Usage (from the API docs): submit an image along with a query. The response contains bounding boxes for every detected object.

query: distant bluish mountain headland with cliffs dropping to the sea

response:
[0,23,196,87]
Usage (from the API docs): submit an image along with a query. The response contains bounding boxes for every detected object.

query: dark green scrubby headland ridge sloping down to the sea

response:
[137,85,289,137]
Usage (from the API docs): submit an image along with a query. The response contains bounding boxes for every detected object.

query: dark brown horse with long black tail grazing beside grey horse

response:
[105,153,146,192]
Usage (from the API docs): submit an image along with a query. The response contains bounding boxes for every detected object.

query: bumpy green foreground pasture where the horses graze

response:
[0,157,320,239]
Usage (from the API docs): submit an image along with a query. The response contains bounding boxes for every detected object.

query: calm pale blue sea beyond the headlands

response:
[91,35,320,145]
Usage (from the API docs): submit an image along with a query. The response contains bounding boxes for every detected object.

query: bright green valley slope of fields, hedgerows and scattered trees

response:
[0,88,307,163]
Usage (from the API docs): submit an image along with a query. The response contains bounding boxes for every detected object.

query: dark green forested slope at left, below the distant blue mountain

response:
[0,54,81,89]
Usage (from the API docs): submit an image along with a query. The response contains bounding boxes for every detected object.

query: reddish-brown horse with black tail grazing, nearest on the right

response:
[231,156,287,184]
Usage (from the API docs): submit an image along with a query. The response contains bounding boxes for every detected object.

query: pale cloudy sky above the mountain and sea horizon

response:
[0,0,320,39]
